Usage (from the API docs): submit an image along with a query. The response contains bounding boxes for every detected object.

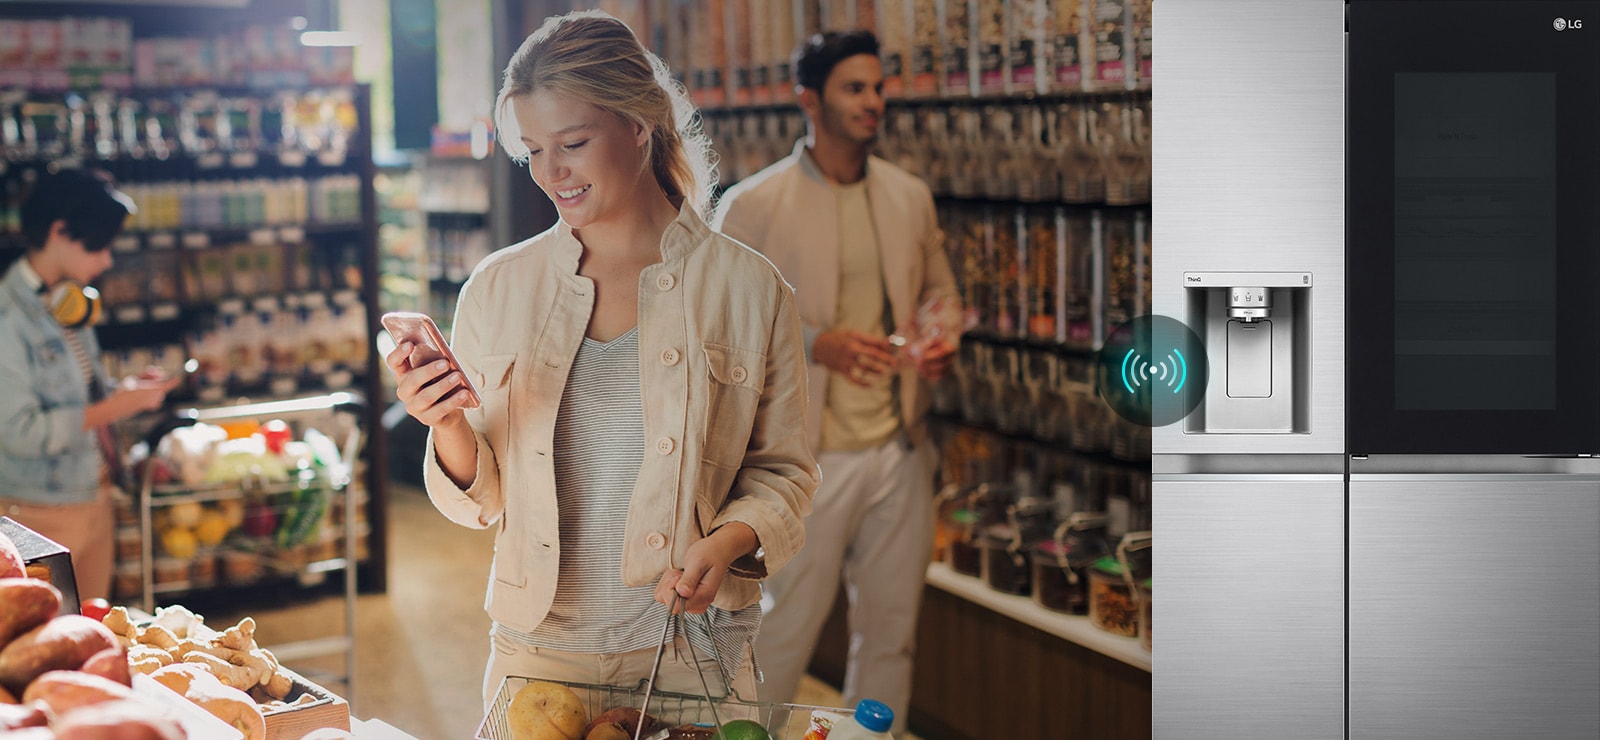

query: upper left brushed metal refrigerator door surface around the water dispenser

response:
[1152,0,1346,453]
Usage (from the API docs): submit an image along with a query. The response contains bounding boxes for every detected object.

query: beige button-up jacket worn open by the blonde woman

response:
[424,202,818,631]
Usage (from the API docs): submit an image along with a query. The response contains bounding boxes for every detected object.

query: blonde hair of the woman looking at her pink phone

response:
[494,10,717,218]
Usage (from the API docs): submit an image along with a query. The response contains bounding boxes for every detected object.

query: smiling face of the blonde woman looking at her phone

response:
[510,90,659,229]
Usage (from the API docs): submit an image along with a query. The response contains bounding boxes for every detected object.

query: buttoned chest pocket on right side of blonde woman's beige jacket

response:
[701,343,766,471]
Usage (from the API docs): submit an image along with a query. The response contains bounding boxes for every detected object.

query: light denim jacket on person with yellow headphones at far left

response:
[0,259,110,505]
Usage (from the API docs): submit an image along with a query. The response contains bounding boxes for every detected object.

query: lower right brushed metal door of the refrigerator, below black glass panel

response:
[1349,479,1600,740]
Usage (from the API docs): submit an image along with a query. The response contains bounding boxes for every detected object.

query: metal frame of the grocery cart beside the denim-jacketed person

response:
[136,392,365,697]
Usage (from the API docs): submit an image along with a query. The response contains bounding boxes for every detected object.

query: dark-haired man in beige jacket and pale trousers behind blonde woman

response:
[712,30,962,729]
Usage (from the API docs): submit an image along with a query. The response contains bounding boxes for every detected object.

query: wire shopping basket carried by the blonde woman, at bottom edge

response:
[477,676,851,740]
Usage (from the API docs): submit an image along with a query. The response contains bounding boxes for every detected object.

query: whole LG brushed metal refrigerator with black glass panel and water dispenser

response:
[1152,0,1600,740]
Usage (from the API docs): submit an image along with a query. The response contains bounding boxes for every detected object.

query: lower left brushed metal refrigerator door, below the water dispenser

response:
[1150,479,1344,740]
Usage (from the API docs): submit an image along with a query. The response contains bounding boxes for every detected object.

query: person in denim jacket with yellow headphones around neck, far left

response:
[0,170,178,599]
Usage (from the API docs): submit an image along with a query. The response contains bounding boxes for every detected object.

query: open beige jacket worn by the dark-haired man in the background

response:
[712,139,962,450]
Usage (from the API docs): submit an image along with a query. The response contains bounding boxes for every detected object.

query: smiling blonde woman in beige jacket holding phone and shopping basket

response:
[387,11,818,705]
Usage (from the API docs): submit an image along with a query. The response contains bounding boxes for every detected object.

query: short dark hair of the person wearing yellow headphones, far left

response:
[21,170,138,251]
